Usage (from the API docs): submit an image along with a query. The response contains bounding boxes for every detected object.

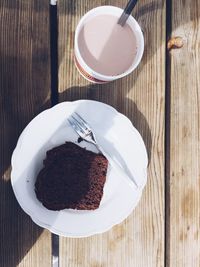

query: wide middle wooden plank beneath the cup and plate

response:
[58,0,165,267]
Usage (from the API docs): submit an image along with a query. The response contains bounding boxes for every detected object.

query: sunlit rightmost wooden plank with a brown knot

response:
[167,0,200,267]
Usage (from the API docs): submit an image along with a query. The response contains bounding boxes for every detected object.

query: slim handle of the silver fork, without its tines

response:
[95,143,140,189]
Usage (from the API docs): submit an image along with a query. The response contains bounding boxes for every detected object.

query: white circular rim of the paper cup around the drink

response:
[74,5,144,80]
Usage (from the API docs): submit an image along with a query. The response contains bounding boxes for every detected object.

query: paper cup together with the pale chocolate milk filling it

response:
[75,6,144,83]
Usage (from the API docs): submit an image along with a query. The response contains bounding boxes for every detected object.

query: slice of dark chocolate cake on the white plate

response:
[35,142,108,210]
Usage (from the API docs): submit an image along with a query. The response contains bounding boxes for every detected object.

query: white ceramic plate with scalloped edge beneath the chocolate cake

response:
[11,100,147,237]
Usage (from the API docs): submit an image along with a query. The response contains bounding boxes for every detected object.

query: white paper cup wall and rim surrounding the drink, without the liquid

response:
[74,6,144,83]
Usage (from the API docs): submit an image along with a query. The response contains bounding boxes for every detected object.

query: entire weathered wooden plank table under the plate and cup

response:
[0,0,200,267]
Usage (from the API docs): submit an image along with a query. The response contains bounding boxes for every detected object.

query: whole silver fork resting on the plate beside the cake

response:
[67,112,139,188]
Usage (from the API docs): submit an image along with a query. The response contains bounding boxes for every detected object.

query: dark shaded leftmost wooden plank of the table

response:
[0,0,51,267]
